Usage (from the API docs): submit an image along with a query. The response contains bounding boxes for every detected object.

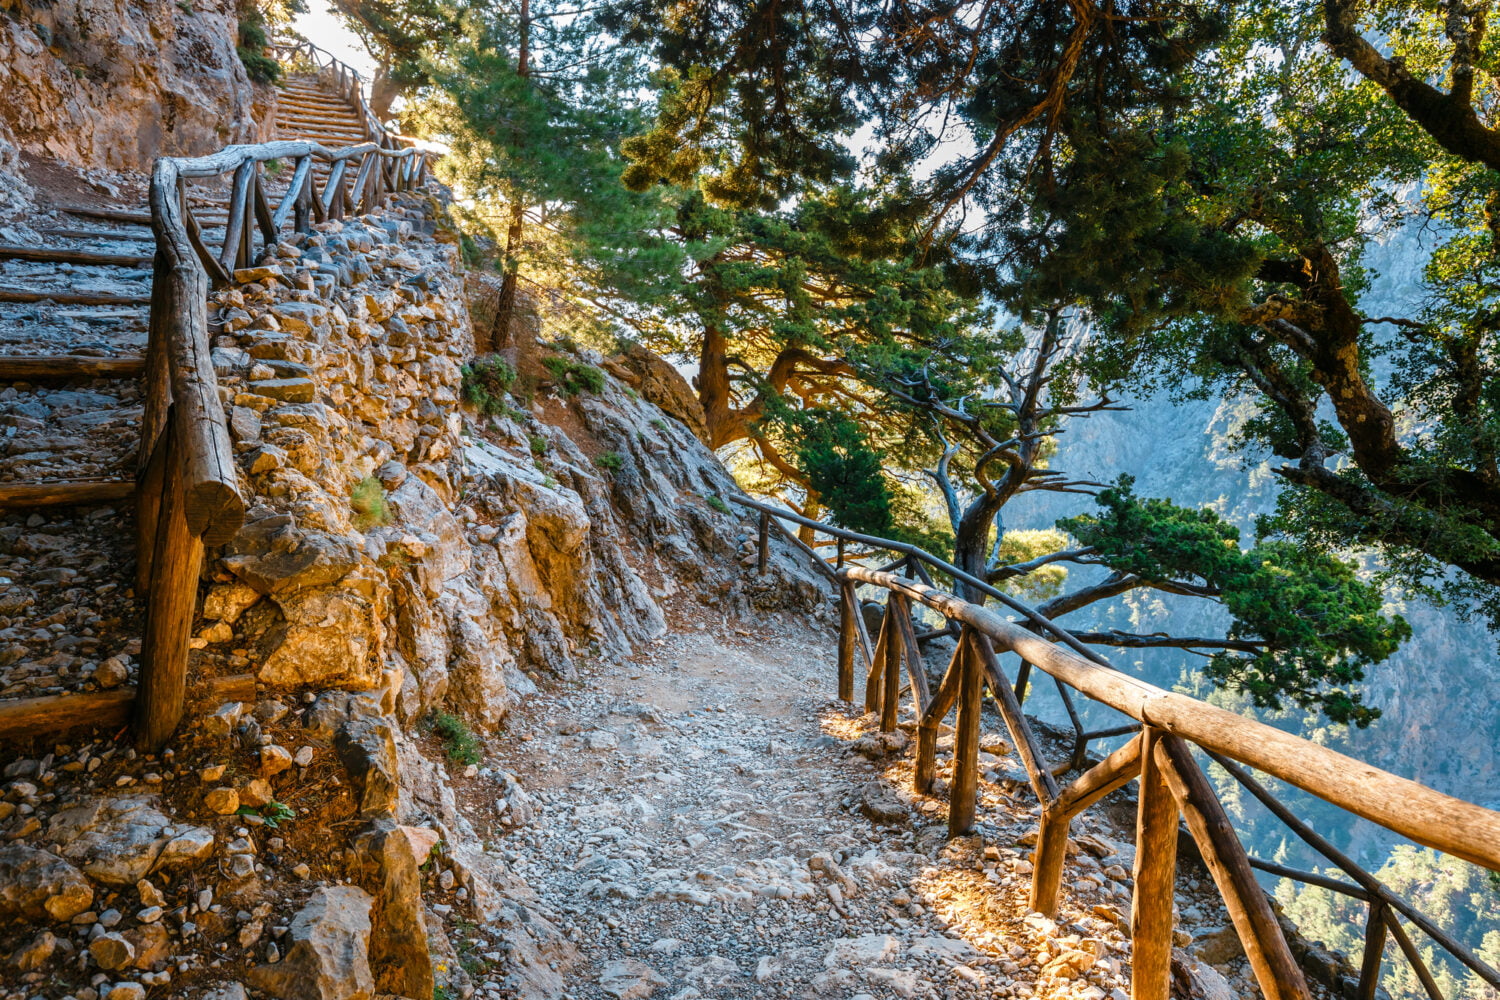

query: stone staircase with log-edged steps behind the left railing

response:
[0,75,381,735]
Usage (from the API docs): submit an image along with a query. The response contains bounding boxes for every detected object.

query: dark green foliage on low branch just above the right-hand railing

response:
[1058,477,1412,727]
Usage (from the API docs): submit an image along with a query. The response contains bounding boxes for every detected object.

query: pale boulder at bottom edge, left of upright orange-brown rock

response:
[248,886,375,1000]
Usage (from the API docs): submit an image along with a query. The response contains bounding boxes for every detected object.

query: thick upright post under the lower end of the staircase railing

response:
[135,408,203,751]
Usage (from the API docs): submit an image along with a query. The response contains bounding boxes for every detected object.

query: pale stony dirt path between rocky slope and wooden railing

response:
[480,611,1130,1000]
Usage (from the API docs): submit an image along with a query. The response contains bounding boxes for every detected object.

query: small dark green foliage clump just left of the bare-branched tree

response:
[797,409,893,537]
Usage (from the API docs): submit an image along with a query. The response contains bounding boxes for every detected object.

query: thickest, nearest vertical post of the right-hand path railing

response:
[1130,727,1178,1000]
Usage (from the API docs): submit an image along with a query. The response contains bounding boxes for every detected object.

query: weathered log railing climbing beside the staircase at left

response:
[134,42,428,748]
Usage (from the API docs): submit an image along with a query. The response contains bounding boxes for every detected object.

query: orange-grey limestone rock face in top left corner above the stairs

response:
[0,0,275,171]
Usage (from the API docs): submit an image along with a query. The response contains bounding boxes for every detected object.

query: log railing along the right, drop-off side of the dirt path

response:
[729,498,1500,1000]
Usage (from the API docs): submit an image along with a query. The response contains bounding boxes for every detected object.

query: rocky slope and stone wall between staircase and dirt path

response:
[0,177,827,1000]
